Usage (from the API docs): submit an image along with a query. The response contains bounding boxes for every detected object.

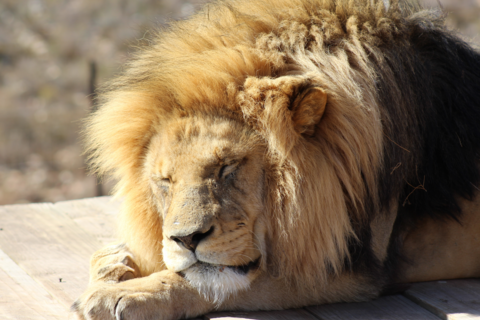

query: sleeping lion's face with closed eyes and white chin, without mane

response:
[146,117,265,300]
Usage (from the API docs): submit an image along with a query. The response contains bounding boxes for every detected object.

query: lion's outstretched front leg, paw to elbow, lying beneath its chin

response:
[72,270,379,320]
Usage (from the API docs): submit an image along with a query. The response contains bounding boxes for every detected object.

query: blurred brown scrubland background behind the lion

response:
[0,0,480,205]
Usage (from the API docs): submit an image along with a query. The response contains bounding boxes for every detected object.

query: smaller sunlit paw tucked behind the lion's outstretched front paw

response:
[90,244,141,285]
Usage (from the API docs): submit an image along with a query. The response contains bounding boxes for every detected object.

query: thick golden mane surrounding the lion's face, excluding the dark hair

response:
[86,0,480,302]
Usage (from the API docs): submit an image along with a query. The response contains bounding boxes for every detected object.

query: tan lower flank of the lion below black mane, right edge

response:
[397,194,480,282]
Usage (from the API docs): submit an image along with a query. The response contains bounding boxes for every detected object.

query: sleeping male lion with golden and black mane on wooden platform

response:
[72,0,480,320]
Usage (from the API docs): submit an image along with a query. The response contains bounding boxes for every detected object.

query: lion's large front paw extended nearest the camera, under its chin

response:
[71,270,208,320]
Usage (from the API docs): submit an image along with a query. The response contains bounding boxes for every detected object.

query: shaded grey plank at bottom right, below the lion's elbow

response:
[306,295,439,320]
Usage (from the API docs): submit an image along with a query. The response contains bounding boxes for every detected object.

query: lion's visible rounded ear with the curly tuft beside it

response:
[237,76,327,155]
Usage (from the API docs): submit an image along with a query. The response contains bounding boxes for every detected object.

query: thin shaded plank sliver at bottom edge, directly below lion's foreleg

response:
[205,309,317,320]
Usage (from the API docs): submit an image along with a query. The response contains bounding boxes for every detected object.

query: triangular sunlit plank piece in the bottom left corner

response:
[0,250,68,320]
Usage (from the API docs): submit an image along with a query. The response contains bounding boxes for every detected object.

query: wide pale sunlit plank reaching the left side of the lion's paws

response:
[0,203,103,307]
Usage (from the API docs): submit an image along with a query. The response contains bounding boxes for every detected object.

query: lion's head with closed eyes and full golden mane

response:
[87,0,480,300]
